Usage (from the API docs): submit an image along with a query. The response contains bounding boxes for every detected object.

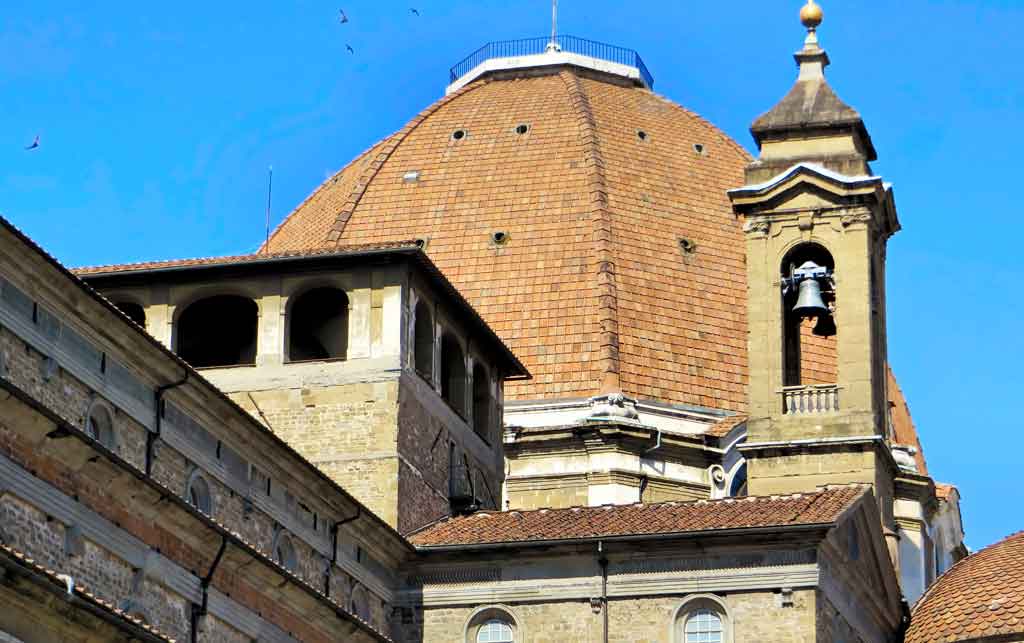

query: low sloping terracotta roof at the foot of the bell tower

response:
[410,485,866,548]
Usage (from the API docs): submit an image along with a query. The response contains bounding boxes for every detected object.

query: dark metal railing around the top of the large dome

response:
[450,36,654,88]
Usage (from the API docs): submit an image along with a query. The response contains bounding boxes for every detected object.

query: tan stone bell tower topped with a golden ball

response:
[729,0,899,527]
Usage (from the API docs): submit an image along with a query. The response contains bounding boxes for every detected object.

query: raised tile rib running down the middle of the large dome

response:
[558,70,622,393]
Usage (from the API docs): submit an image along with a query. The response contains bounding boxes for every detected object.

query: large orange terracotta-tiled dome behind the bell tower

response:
[269,68,751,411]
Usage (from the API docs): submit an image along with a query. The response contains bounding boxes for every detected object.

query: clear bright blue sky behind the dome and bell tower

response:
[0,0,1024,548]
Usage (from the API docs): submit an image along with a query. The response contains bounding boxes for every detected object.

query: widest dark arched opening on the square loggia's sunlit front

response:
[177,295,259,368]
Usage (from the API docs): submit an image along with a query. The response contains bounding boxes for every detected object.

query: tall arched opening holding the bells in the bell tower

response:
[780,243,839,387]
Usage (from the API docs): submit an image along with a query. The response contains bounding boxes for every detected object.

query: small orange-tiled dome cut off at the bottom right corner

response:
[905,531,1024,643]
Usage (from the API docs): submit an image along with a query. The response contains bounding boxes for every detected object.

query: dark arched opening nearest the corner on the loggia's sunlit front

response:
[288,288,348,361]
